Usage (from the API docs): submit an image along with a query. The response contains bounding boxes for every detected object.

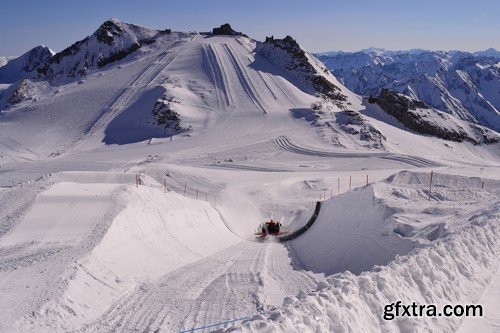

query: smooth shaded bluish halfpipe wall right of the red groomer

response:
[289,186,418,275]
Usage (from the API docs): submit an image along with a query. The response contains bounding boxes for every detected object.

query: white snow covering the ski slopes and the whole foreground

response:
[0,20,500,332]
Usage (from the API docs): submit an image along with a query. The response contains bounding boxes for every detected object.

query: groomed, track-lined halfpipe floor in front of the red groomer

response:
[82,242,315,332]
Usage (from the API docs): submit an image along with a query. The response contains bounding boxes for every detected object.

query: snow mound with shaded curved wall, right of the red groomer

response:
[289,171,498,275]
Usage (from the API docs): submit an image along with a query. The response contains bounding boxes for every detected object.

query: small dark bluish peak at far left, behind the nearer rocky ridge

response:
[0,45,54,83]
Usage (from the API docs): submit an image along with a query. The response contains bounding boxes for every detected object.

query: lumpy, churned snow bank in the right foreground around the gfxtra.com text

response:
[228,189,500,332]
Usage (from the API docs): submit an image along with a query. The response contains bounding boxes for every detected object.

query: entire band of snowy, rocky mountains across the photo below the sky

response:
[0,19,500,156]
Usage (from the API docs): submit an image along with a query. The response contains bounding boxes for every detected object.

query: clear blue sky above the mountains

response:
[0,0,500,56]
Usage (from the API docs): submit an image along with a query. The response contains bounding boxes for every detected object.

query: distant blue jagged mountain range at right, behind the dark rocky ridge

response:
[319,50,500,131]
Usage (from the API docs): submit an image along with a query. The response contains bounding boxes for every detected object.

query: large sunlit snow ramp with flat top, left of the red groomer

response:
[0,173,241,332]
